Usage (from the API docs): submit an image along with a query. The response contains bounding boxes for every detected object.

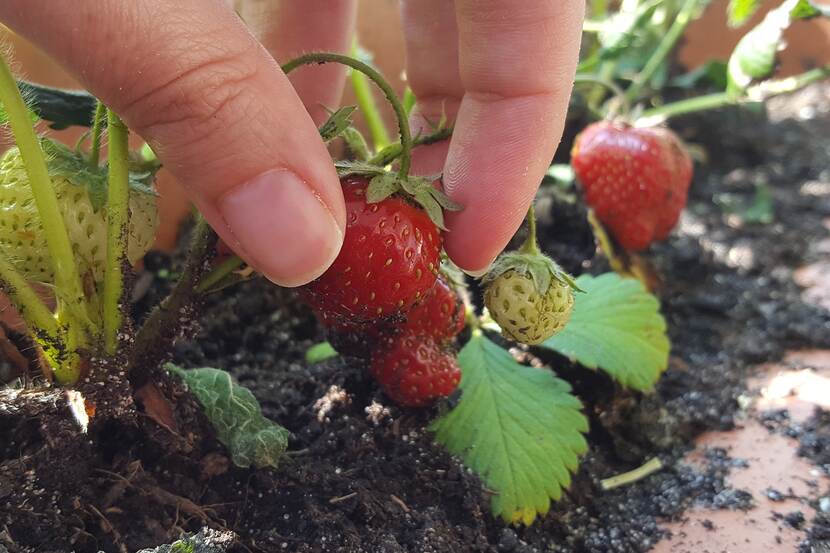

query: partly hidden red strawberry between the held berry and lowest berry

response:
[404,276,465,343]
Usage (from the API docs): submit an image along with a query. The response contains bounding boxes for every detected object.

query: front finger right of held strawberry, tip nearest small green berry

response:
[444,0,585,272]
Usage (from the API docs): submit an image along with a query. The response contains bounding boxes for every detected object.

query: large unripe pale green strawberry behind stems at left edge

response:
[0,144,158,283]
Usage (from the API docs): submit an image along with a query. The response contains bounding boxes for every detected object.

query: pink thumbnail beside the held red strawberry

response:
[217,169,343,286]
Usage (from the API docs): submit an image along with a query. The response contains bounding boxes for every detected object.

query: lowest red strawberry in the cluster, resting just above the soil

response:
[371,331,461,407]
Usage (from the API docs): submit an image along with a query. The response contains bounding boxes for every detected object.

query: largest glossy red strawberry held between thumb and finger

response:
[301,176,441,326]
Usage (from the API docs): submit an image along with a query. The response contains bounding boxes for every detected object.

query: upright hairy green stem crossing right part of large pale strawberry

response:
[103,110,130,355]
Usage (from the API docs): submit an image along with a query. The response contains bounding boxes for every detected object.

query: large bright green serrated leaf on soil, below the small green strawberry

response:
[431,332,588,524]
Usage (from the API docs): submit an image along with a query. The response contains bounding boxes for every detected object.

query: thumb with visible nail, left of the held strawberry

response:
[0,0,345,286]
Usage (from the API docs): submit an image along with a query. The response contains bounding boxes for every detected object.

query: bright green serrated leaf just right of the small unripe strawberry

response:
[542,273,670,391]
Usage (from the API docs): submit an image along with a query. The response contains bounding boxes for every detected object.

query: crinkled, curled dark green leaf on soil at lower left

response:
[165,363,288,468]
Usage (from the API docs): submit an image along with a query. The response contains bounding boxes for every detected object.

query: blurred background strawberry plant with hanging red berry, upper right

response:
[568,0,830,260]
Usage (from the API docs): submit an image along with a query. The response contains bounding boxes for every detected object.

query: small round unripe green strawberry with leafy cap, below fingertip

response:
[484,252,575,345]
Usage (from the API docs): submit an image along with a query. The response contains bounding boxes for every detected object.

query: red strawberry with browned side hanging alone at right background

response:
[571,121,692,251]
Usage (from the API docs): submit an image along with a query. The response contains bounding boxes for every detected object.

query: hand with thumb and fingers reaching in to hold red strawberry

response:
[0,0,584,286]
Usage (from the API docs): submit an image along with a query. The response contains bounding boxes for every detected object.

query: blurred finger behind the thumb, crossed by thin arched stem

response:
[242,0,357,125]
